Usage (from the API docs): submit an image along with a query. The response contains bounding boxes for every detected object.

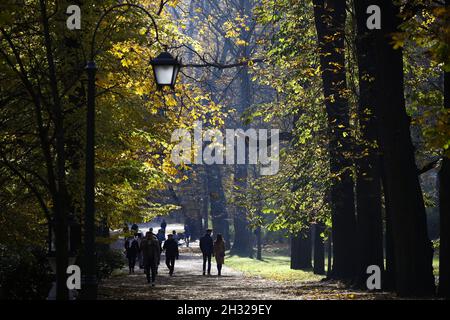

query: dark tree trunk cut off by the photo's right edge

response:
[438,67,450,298]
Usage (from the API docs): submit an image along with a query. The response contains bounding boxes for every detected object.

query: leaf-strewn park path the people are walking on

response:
[98,247,387,300]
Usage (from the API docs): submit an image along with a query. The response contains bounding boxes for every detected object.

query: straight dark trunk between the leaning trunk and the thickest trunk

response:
[355,0,384,286]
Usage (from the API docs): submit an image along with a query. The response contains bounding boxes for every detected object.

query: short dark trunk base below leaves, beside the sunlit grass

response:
[291,228,312,270]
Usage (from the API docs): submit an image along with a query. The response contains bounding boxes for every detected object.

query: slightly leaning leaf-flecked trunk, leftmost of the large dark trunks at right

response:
[313,0,357,279]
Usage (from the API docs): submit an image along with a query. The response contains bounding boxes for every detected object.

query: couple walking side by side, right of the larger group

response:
[200,229,225,276]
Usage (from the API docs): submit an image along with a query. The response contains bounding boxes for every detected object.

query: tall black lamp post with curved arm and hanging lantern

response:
[82,3,181,300]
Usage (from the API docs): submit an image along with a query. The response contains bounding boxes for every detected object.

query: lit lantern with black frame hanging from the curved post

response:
[150,52,181,89]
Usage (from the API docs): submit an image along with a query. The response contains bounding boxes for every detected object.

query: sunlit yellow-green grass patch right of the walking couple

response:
[225,252,324,282]
